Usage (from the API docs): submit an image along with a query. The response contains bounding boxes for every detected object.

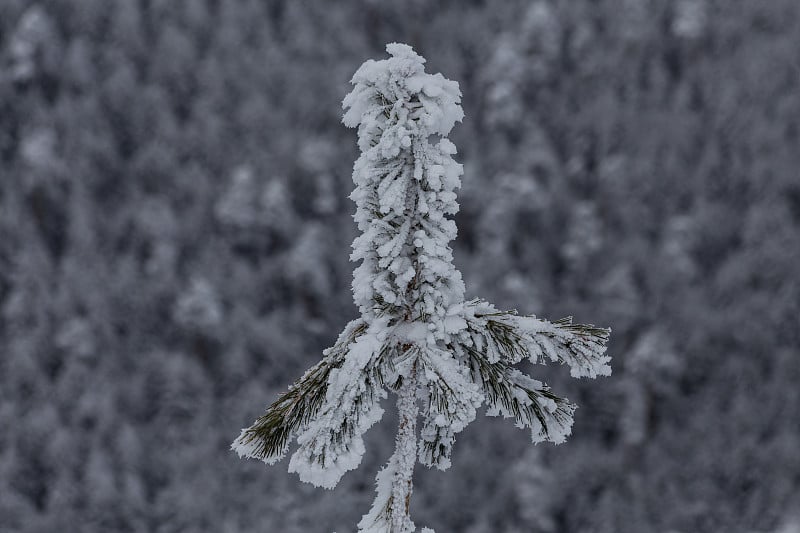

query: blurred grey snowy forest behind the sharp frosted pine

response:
[0,0,800,533]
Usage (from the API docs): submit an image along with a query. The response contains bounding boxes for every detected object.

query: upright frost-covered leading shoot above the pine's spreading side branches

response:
[344,43,464,339]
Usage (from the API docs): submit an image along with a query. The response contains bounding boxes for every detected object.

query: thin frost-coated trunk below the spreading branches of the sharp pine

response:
[391,364,419,533]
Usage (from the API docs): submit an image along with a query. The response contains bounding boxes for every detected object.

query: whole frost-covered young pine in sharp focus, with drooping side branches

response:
[232,43,611,533]
